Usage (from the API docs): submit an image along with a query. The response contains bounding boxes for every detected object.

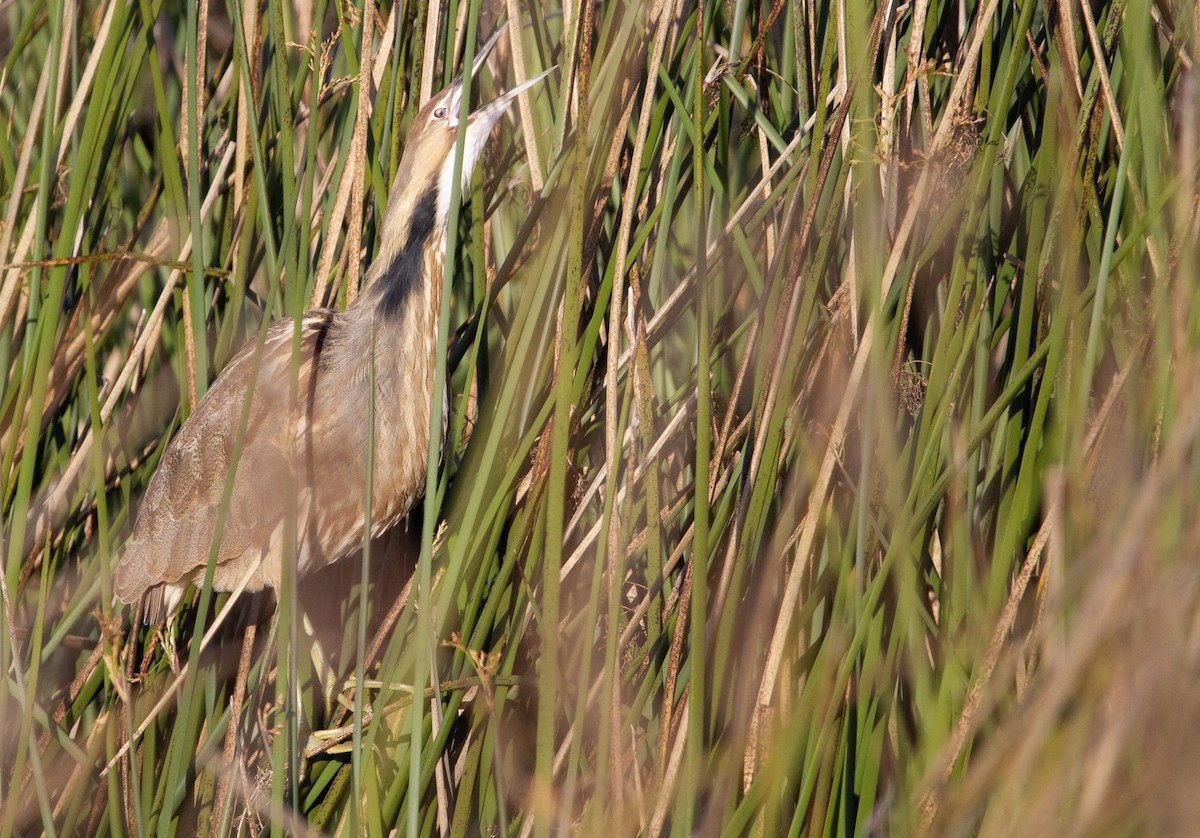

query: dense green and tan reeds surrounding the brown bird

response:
[0,0,1200,836]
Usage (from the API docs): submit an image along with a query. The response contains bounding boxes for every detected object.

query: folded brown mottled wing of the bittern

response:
[114,310,337,601]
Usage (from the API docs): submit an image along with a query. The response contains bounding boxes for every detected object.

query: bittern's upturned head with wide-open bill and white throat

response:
[384,29,553,238]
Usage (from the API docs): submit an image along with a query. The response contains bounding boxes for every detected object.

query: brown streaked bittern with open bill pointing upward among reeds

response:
[113,32,550,623]
